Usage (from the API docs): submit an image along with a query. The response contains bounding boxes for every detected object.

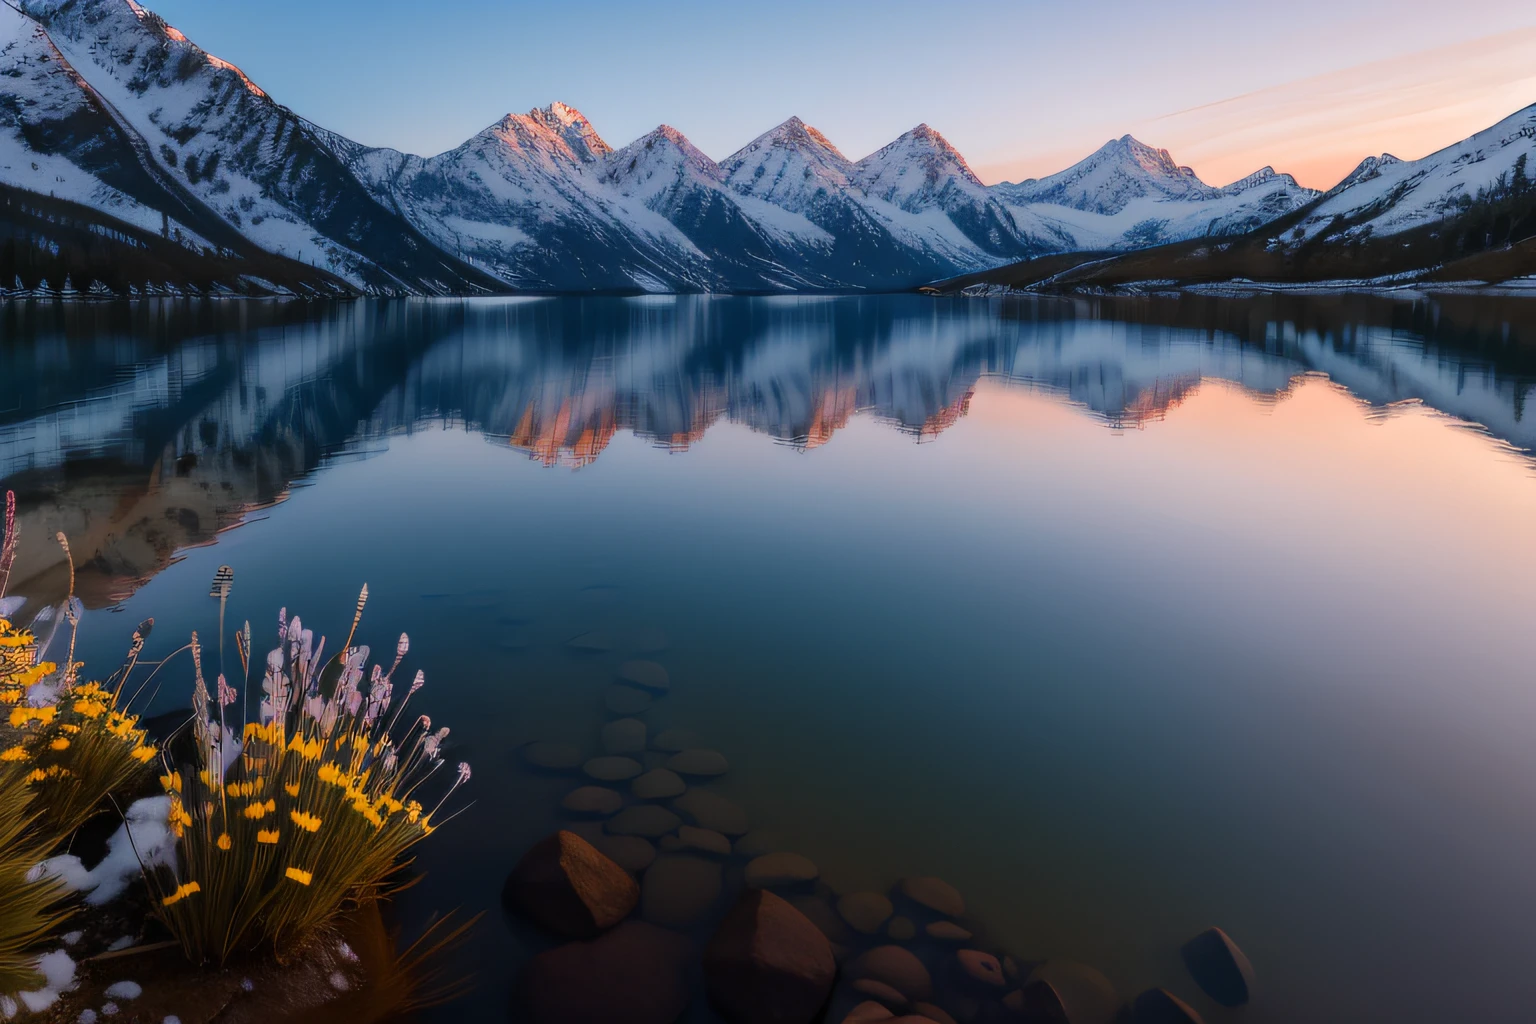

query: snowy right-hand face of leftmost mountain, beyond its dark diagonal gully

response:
[22,0,497,292]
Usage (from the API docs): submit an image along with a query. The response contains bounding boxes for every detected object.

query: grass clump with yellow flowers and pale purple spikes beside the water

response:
[149,586,470,964]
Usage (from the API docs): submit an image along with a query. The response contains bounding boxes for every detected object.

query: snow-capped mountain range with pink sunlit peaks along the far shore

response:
[0,0,1530,295]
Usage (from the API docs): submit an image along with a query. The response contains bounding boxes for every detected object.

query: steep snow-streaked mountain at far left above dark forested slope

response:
[0,0,496,292]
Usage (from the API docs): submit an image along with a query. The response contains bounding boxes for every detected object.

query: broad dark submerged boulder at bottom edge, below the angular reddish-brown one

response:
[519,921,694,1024]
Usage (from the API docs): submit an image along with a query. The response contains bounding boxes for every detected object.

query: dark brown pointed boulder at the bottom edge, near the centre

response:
[703,890,837,1024]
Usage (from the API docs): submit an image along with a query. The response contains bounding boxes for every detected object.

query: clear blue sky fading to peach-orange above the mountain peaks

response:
[146,0,1536,187]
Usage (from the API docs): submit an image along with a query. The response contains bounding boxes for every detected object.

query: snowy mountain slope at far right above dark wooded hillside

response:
[1295,104,1536,241]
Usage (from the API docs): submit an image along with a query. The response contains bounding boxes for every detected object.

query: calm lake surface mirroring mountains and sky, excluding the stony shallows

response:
[0,296,1536,1024]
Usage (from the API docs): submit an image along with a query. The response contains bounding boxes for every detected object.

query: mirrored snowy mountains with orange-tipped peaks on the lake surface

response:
[0,296,1536,606]
